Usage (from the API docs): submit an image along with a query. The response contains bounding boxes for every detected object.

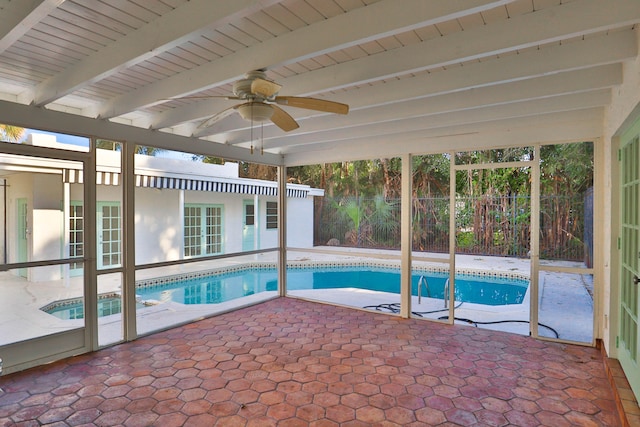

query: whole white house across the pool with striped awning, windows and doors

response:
[0,134,324,281]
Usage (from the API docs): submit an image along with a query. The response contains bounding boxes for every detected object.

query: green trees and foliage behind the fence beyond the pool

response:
[288,142,593,259]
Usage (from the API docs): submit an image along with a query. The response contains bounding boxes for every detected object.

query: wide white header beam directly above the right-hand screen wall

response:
[284,108,604,167]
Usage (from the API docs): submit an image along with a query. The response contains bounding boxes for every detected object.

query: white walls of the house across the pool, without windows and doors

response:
[7,145,322,281]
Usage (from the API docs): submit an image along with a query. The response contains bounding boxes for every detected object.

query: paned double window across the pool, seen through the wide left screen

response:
[184,204,223,258]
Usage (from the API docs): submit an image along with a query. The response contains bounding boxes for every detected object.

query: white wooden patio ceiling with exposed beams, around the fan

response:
[0,0,640,165]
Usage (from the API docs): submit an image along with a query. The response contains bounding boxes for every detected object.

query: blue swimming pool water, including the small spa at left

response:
[41,266,529,319]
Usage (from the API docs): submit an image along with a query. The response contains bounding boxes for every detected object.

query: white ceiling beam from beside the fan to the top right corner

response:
[280,0,640,95]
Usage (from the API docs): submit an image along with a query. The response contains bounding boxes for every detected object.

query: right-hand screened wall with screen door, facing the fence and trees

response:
[287,143,594,345]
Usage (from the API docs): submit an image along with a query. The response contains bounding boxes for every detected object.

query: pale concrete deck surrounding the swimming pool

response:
[0,247,594,345]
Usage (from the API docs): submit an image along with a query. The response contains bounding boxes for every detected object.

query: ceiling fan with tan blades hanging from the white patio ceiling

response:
[198,70,349,132]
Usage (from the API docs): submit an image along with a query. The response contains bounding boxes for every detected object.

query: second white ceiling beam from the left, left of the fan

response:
[32,0,277,105]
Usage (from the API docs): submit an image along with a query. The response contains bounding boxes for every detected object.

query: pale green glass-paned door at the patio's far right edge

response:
[617,119,640,402]
